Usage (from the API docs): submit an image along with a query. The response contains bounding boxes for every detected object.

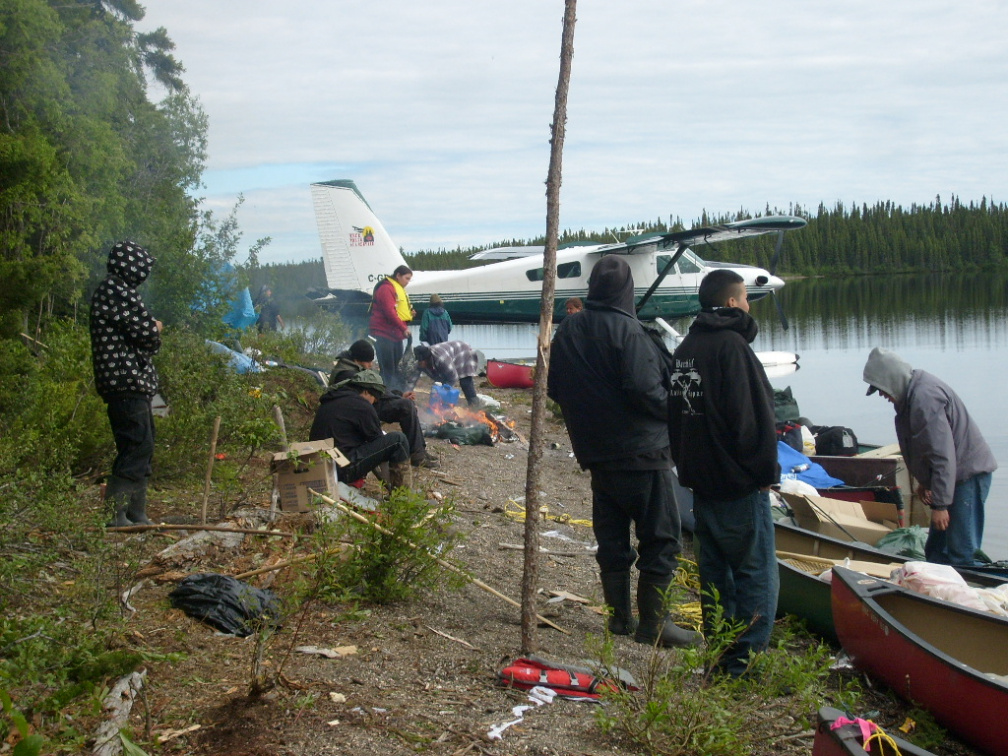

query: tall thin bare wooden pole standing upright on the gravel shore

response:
[521,0,578,654]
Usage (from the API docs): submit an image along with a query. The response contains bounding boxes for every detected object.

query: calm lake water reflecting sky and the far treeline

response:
[413,271,1008,559]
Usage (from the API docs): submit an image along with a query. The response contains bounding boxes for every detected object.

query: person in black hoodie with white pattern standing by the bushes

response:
[90,241,161,527]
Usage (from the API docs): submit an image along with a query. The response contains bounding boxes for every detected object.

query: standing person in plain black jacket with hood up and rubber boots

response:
[547,255,701,646]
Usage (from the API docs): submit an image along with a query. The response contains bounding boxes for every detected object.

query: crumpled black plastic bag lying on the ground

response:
[168,573,280,638]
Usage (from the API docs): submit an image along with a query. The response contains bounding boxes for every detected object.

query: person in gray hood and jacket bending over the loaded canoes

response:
[863,347,998,566]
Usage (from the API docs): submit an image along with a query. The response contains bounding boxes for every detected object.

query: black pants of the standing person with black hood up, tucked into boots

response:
[592,470,682,582]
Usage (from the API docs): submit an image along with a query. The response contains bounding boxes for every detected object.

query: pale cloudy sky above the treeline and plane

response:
[138,0,1008,263]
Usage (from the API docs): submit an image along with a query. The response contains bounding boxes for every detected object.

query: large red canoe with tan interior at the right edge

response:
[833,566,1008,754]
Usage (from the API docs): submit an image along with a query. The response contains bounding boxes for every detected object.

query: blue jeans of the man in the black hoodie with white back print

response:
[694,490,779,676]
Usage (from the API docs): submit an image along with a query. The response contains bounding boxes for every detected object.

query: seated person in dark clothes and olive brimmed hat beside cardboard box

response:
[308,370,413,488]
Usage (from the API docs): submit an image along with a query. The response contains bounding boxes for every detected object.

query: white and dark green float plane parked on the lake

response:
[311,179,805,328]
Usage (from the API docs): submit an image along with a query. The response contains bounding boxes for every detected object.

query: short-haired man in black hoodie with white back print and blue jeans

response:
[669,268,780,677]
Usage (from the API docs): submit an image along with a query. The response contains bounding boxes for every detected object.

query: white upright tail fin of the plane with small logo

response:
[311,179,405,294]
